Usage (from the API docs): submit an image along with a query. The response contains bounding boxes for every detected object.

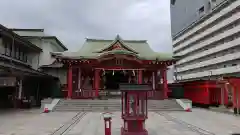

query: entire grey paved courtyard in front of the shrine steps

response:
[0,109,240,135]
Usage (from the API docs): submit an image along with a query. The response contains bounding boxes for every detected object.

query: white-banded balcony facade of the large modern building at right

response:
[173,0,240,81]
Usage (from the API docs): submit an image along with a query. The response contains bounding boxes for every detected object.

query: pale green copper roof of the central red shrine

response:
[58,36,173,61]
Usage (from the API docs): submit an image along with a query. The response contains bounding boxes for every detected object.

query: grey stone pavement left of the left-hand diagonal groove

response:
[0,110,77,135]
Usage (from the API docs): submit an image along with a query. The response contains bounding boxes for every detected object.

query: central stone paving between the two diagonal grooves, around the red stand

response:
[68,112,201,135]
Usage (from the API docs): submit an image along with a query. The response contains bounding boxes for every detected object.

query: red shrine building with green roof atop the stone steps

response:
[52,35,176,99]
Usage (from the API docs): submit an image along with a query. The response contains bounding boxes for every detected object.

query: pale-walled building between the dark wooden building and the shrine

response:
[13,29,67,84]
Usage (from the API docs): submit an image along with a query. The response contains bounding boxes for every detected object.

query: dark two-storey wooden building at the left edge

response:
[0,25,57,109]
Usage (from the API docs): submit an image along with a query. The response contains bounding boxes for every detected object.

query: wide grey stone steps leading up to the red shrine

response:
[53,99,184,112]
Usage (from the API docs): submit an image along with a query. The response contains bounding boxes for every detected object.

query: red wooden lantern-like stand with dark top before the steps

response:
[120,84,151,135]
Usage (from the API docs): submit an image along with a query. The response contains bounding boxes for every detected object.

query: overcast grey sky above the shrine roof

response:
[0,0,172,52]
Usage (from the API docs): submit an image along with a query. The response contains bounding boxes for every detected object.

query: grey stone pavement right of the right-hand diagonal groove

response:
[169,108,240,135]
